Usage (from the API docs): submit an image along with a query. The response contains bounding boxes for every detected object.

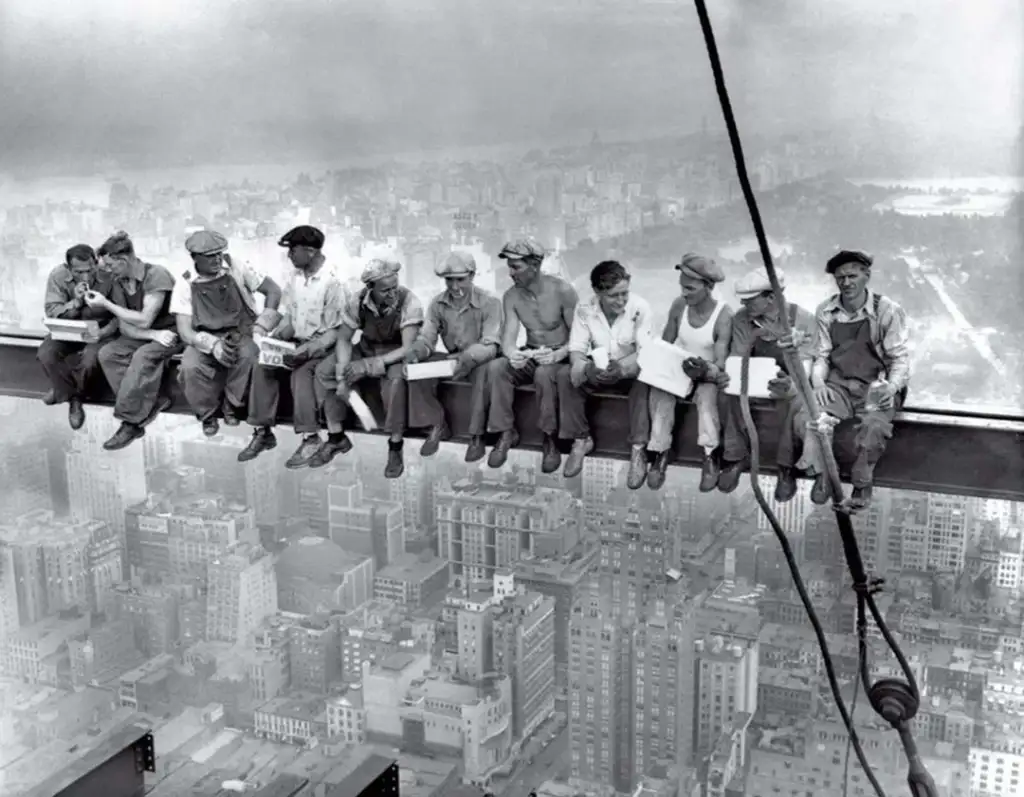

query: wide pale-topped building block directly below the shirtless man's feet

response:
[436,471,581,588]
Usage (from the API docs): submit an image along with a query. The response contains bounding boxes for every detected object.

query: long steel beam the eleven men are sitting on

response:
[0,339,1024,501]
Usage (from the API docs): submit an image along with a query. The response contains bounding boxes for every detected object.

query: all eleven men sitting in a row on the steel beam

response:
[39,225,909,503]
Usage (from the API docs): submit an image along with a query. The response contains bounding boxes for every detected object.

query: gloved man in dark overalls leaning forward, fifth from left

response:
[323,258,423,478]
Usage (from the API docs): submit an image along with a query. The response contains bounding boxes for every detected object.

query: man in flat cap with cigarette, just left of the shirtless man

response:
[406,247,503,462]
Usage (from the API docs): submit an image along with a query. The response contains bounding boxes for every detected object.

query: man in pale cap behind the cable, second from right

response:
[718,266,817,501]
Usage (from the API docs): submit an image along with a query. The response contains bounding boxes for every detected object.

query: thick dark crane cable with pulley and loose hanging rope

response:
[694,0,938,786]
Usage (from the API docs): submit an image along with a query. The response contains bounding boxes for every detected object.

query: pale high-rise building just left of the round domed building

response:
[206,543,278,642]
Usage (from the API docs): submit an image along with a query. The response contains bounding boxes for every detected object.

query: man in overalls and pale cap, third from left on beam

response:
[171,229,281,437]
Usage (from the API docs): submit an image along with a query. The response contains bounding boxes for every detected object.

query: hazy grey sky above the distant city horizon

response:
[0,0,1024,166]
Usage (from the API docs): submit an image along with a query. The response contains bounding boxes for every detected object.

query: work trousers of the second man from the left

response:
[99,336,184,426]
